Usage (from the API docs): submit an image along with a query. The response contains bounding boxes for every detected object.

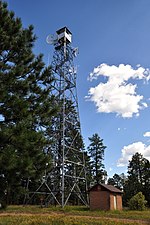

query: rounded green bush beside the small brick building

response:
[128,192,147,210]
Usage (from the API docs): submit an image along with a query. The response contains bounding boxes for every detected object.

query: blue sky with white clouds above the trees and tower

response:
[7,0,150,176]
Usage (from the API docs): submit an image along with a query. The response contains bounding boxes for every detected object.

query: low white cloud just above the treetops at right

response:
[117,142,150,167]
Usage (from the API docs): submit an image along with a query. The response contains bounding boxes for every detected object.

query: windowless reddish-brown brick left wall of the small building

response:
[90,191,110,210]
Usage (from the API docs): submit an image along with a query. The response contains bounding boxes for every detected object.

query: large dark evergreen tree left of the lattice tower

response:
[0,1,55,202]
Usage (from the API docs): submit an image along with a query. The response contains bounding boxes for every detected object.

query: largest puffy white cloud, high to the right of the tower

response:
[87,64,150,118]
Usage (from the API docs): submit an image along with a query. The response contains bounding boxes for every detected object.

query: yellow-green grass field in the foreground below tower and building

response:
[0,206,150,225]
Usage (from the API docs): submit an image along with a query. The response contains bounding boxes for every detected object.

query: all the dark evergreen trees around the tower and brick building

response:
[0,1,150,205]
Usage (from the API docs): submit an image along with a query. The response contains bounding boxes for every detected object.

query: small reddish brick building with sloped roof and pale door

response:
[89,184,123,210]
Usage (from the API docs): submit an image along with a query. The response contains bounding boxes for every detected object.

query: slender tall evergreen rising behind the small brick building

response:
[88,133,106,183]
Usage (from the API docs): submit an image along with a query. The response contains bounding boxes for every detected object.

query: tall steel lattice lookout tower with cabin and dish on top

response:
[47,27,87,207]
